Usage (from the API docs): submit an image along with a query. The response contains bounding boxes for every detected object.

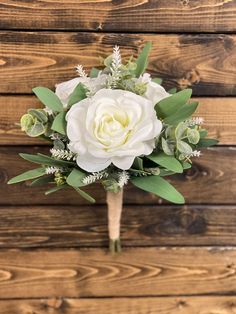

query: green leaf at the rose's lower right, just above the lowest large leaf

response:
[146,153,183,173]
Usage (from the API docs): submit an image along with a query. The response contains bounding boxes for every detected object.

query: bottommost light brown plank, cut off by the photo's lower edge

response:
[0,296,236,314]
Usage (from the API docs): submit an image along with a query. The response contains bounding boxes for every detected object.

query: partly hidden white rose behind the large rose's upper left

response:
[55,74,107,107]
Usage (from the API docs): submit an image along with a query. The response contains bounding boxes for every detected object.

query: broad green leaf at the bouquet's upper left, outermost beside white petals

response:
[33,86,63,112]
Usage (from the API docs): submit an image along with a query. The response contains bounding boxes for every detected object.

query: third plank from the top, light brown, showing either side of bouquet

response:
[0,95,236,145]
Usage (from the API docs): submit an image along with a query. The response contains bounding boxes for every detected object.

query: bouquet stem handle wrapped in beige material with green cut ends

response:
[107,189,123,253]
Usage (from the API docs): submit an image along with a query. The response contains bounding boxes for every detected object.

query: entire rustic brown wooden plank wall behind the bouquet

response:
[0,0,236,314]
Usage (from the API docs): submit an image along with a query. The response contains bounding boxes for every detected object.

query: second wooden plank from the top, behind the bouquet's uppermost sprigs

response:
[0,31,236,96]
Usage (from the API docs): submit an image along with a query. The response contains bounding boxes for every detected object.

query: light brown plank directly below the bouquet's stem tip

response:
[0,247,236,299]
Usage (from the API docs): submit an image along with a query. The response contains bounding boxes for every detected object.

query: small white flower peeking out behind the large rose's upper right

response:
[138,73,170,105]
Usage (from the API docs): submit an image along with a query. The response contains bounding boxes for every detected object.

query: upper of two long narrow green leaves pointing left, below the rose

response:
[19,153,75,167]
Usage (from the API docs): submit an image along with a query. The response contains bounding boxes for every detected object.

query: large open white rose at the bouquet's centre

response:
[66,89,162,172]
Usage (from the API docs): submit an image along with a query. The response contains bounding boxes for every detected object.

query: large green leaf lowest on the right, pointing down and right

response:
[131,176,185,204]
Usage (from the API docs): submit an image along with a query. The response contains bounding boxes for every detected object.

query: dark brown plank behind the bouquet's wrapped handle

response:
[0,205,236,248]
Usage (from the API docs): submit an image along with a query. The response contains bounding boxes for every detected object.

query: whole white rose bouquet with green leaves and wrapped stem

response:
[8,42,217,251]
